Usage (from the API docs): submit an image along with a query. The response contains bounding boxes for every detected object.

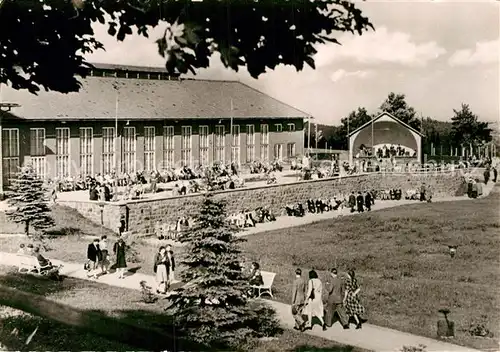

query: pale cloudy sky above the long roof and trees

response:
[87,0,500,125]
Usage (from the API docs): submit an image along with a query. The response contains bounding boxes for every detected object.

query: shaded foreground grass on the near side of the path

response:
[0,266,364,352]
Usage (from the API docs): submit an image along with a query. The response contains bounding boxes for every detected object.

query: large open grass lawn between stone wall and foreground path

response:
[243,192,500,350]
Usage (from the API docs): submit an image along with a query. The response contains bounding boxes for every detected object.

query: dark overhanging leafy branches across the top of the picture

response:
[0,0,373,93]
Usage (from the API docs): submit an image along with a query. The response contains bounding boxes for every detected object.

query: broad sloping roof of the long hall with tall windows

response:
[2,76,309,119]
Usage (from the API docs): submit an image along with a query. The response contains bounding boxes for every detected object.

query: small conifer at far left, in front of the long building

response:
[6,165,55,236]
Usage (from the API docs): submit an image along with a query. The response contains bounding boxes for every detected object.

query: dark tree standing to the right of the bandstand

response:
[451,104,492,146]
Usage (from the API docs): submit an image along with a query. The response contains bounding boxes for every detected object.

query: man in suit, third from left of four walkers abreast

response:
[325,268,349,329]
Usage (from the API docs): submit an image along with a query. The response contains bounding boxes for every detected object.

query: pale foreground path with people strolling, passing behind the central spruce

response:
[0,252,479,352]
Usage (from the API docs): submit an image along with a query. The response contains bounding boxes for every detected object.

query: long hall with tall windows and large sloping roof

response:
[0,65,309,187]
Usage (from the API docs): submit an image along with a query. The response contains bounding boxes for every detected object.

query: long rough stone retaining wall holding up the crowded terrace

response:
[60,172,465,235]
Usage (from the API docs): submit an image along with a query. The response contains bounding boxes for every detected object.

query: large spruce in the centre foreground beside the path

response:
[167,195,281,349]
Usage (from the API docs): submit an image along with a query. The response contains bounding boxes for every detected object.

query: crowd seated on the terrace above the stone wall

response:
[47,153,491,201]
